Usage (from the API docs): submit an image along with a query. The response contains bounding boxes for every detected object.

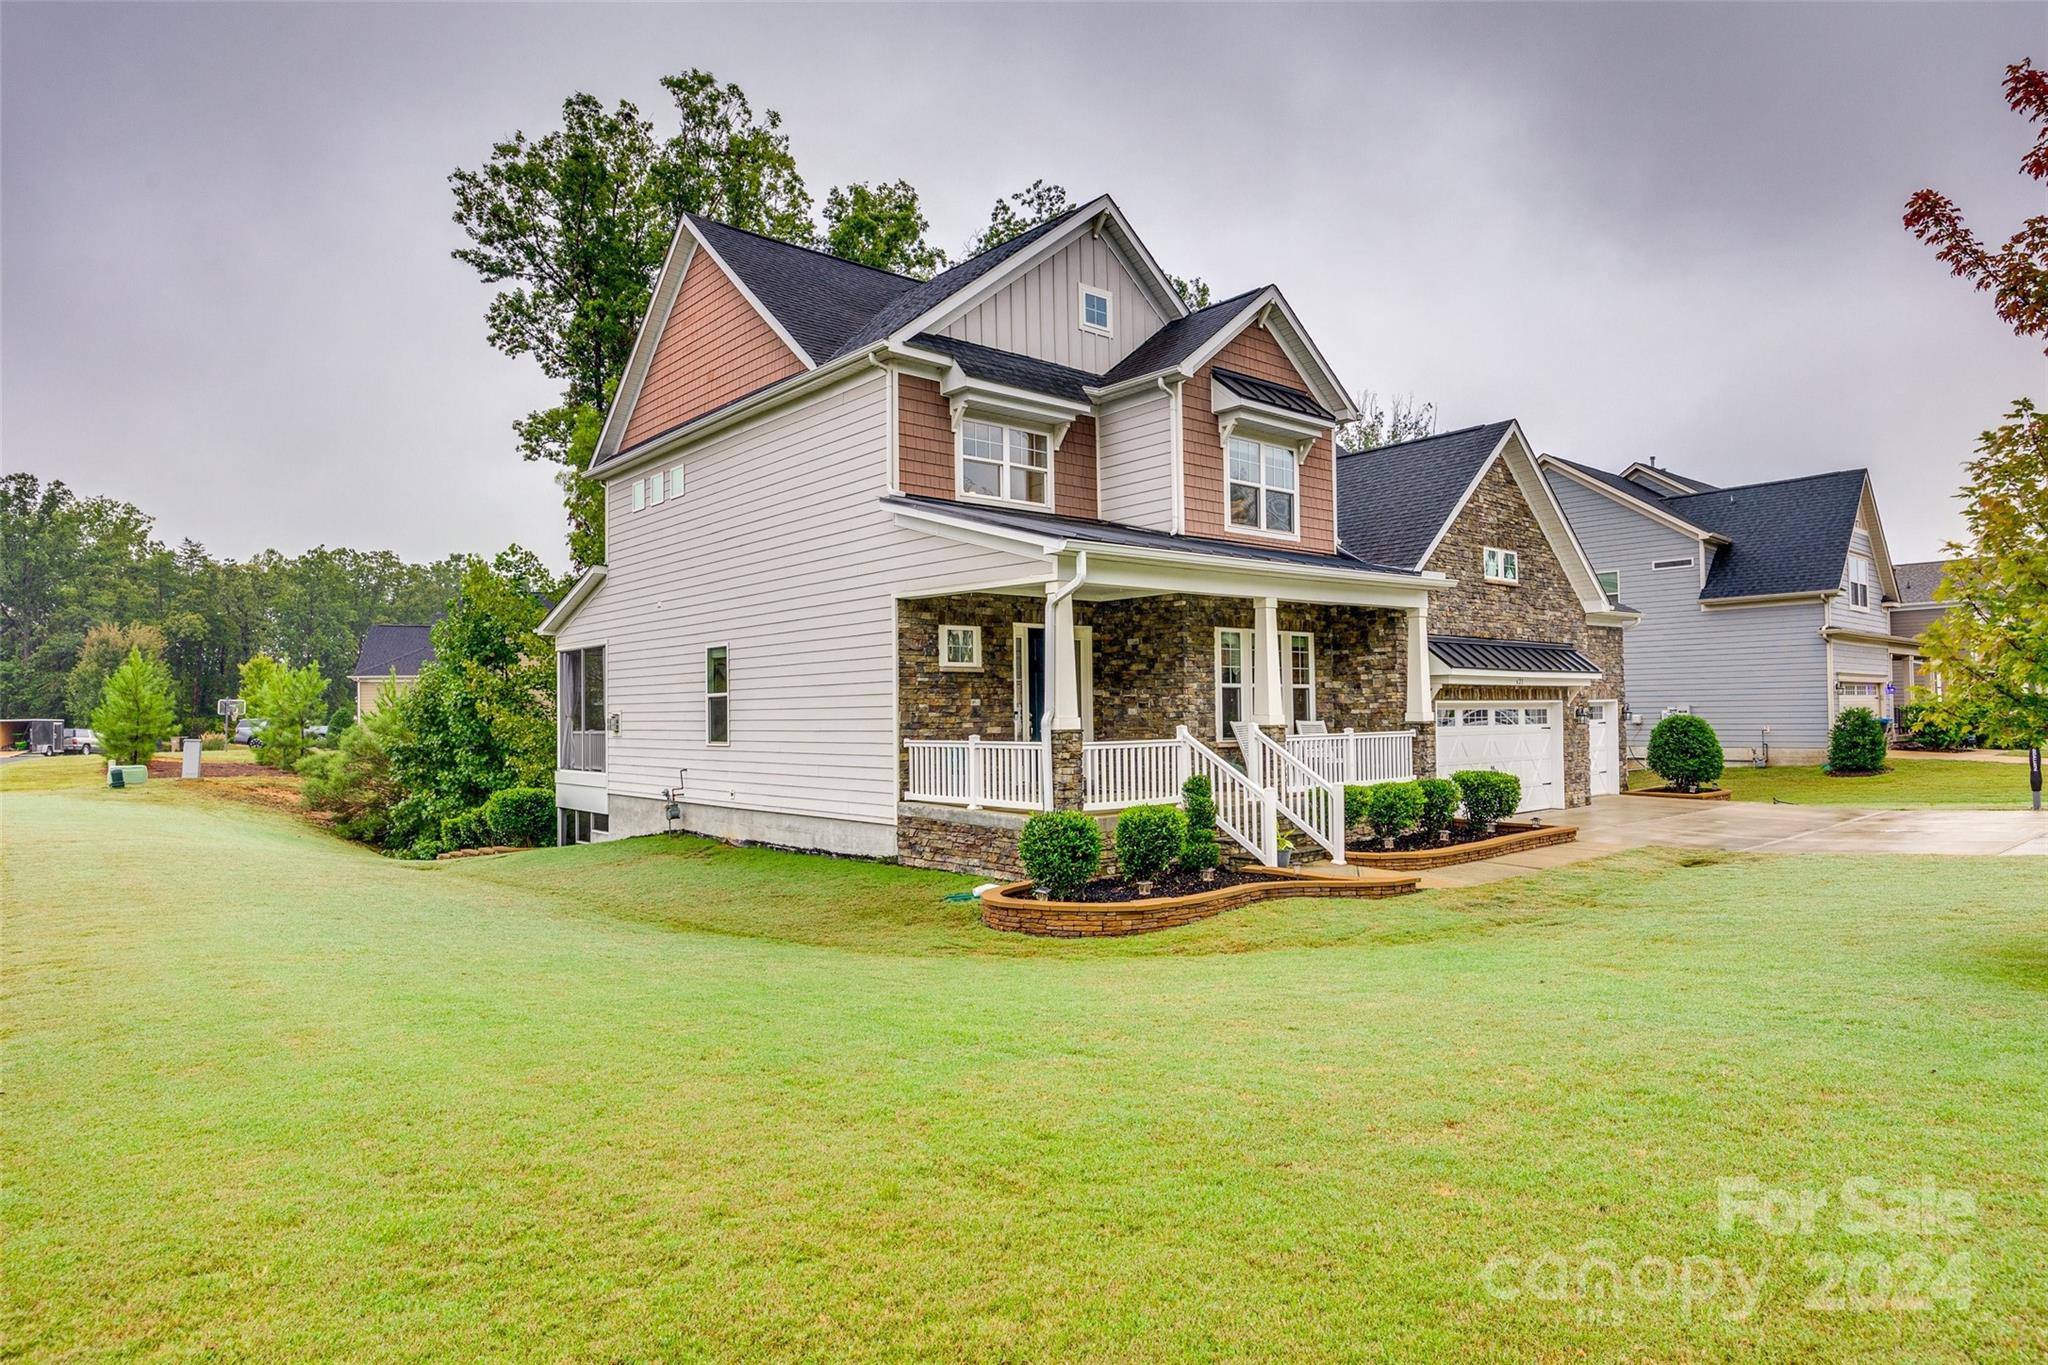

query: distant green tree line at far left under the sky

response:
[0,473,465,735]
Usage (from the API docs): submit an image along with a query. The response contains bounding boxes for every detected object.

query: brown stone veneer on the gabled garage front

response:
[1417,463,1628,806]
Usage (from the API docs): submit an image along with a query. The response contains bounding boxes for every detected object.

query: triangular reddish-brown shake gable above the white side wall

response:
[621,250,805,450]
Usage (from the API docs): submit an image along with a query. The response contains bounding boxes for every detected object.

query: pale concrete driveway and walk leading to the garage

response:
[1421,796,2048,886]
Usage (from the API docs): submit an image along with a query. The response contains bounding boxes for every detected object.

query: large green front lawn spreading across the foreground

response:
[12,767,2048,1361]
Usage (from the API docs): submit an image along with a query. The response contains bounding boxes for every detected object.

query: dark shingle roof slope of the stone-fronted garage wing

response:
[1337,422,1513,569]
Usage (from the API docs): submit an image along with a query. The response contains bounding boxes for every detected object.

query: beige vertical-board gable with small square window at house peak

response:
[940,233,1165,375]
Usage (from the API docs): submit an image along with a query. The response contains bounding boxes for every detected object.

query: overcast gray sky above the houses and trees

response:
[0,4,2048,565]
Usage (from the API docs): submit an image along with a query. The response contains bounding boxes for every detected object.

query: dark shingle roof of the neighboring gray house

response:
[1665,469,1870,600]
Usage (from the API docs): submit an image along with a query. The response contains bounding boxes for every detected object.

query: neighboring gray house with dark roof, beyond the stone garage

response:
[1542,454,1915,763]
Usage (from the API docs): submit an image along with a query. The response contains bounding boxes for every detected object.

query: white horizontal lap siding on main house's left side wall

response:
[557,372,1026,825]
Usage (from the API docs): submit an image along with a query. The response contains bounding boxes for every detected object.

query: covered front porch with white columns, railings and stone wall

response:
[897,536,1430,862]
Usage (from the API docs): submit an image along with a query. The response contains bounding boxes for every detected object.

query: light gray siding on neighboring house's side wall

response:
[1544,473,1833,757]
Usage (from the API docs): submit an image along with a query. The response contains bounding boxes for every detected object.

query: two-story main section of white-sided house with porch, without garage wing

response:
[543,196,1604,868]
